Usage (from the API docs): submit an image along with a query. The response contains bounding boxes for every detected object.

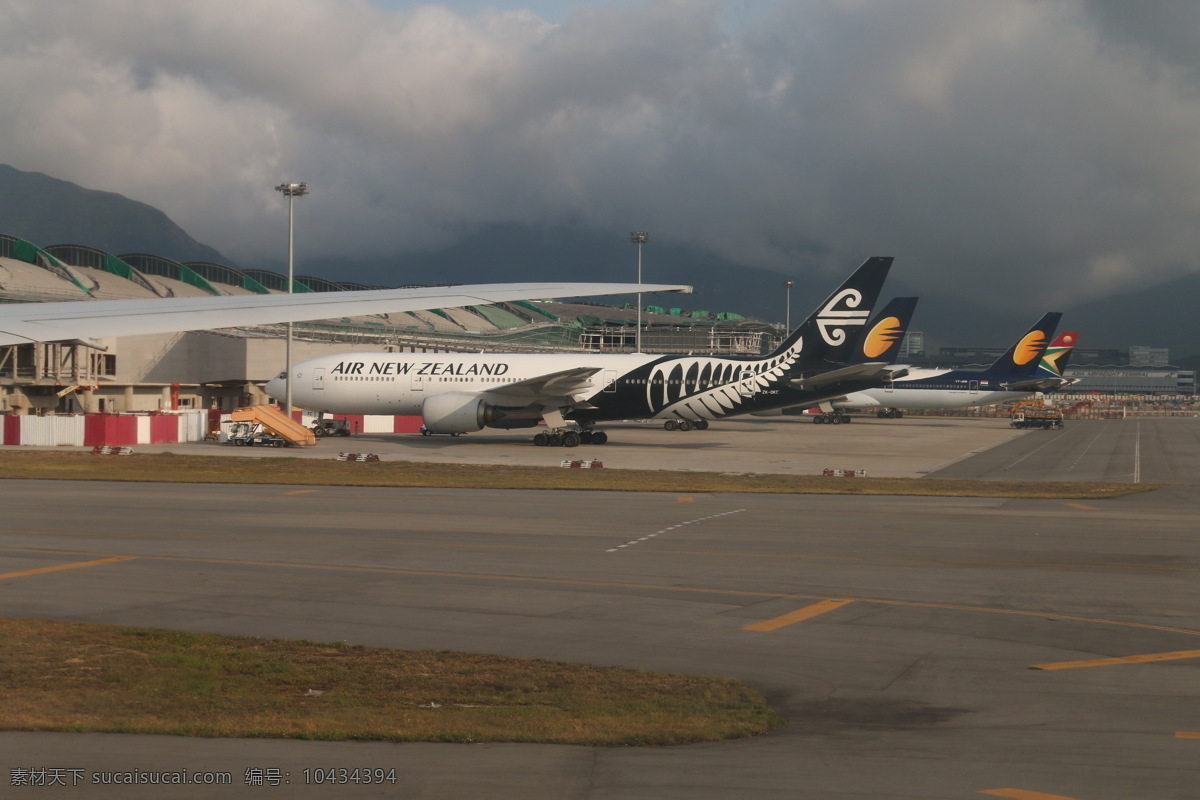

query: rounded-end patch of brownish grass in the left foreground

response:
[0,618,784,746]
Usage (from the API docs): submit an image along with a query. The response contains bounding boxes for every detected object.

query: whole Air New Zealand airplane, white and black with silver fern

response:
[266,257,912,447]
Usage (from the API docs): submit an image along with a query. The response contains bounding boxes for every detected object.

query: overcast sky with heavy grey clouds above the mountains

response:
[0,0,1200,309]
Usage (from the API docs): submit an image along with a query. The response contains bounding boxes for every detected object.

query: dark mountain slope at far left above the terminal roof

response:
[0,164,229,264]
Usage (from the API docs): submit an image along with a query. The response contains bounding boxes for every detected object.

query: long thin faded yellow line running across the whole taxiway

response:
[7,547,1200,637]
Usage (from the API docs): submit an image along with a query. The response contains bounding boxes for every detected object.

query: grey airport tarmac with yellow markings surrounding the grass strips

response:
[0,417,1200,800]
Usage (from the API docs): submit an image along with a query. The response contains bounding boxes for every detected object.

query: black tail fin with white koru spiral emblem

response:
[768,255,894,363]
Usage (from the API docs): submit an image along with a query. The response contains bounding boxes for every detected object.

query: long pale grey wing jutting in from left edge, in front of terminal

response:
[0,283,691,345]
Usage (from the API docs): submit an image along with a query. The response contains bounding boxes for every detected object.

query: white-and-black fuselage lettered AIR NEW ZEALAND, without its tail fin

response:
[276,347,870,431]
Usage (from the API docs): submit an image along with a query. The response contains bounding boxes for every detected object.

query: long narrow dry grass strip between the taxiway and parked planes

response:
[0,451,1162,500]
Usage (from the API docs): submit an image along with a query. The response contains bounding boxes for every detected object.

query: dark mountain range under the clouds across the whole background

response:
[0,164,1200,363]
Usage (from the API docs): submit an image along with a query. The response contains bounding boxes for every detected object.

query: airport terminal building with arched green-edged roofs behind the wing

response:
[0,235,780,414]
